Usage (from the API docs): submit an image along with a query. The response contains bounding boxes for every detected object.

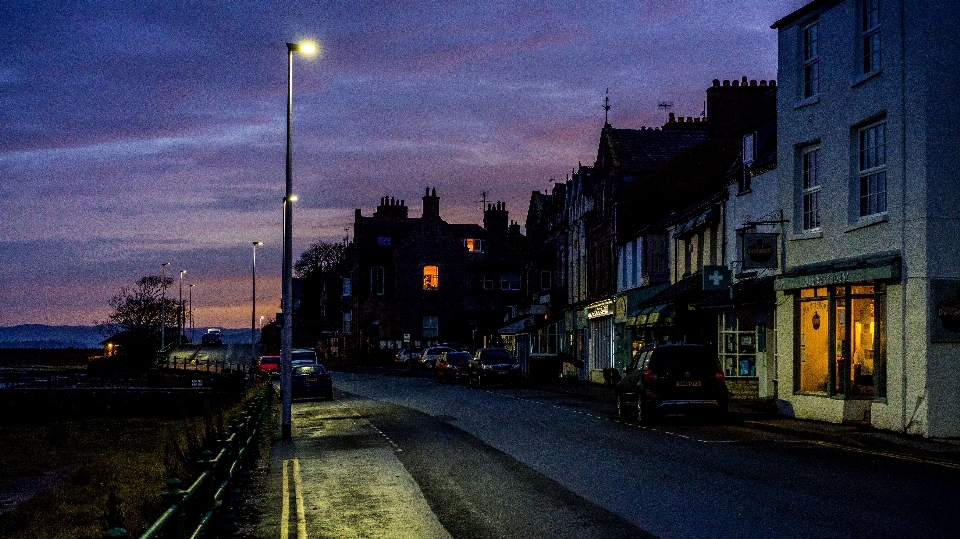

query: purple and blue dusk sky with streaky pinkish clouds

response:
[0,0,807,328]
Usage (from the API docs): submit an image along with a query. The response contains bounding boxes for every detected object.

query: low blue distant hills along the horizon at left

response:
[0,324,250,348]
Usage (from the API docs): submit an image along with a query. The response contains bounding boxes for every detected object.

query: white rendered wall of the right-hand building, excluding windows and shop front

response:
[777,0,960,437]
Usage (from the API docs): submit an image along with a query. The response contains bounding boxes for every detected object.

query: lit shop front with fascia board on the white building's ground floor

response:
[774,257,900,428]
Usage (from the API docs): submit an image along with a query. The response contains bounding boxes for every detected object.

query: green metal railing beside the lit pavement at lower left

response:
[103,384,273,539]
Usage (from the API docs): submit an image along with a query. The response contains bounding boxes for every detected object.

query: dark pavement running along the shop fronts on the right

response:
[531,379,960,468]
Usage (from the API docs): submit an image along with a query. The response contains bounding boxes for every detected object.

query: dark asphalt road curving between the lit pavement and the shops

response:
[268,373,960,538]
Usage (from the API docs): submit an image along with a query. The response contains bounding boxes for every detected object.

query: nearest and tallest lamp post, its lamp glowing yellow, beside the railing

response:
[280,42,317,440]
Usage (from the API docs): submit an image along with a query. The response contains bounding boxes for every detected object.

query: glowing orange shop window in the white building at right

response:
[796,283,886,398]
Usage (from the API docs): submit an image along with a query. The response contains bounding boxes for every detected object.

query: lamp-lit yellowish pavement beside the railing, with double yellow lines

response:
[257,401,450,539]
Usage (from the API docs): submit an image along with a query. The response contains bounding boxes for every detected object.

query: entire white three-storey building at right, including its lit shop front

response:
[773,0,960,437]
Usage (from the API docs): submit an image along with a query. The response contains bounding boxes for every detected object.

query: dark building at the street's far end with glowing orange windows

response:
[341,188,523,357]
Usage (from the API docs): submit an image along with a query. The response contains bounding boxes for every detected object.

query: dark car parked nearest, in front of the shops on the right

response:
[614,344,729,423]
